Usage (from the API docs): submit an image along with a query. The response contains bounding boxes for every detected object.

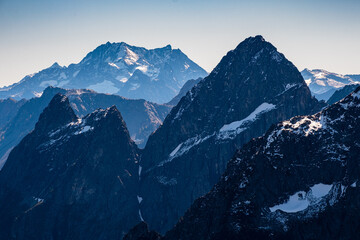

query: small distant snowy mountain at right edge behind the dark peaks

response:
[301,68,360,101]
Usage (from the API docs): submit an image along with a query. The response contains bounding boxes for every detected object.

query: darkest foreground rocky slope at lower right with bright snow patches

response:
[164,88,360,240]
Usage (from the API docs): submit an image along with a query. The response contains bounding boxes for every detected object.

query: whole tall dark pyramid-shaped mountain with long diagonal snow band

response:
[140,36,321,232]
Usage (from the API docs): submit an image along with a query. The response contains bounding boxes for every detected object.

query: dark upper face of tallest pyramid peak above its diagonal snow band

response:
[146,36,316,153]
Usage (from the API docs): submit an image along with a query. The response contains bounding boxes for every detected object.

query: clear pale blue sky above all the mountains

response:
[0,0,360,86]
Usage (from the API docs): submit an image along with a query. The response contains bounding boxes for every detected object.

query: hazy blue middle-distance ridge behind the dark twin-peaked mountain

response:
[0,87,171,169]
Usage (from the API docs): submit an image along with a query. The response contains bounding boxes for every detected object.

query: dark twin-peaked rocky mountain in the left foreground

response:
[0,94,140,239]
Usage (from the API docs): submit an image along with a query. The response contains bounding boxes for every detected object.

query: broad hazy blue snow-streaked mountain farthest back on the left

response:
[0,42,207,103]
